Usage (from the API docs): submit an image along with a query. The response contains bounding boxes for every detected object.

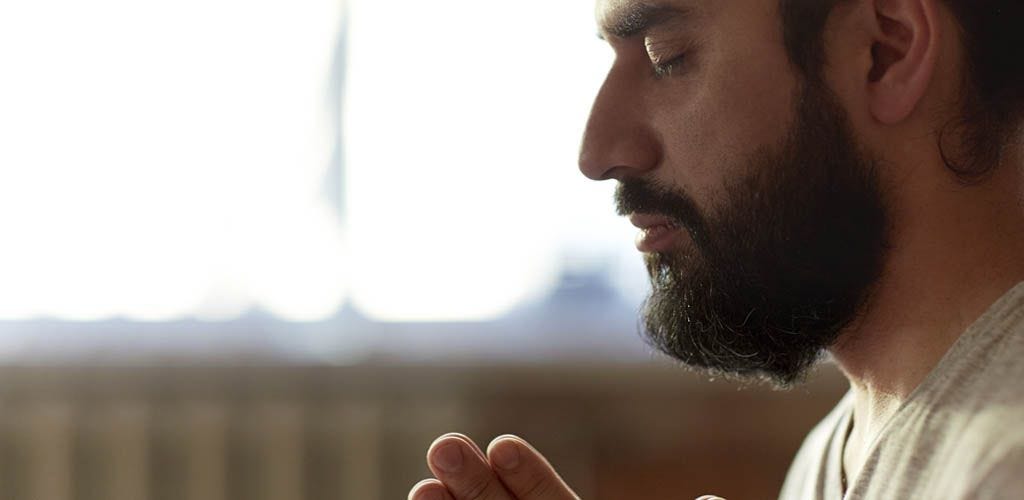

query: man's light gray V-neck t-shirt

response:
[779,283,1024,500]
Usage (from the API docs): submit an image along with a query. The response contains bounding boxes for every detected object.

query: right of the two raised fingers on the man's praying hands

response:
[487,435,580,500]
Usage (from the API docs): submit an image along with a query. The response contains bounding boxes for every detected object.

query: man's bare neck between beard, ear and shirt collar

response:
[831,154,1024,443]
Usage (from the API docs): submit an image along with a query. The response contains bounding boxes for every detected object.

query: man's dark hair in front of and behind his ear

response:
[779,0,1024,182]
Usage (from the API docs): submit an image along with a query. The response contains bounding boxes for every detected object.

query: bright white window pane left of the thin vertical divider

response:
[0,0,347,321]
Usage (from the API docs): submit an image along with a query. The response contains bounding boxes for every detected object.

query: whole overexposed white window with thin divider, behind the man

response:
[0,0,644,358]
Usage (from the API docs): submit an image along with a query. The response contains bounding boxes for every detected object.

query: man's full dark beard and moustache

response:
[615,82,888,387]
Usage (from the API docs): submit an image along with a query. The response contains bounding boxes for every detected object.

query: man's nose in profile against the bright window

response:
[580,68,662,180]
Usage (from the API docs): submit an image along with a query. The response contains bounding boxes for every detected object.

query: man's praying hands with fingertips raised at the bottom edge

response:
[409,433,580,500]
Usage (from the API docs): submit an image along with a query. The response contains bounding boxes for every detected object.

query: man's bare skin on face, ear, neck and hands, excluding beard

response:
[410,0,1024,500]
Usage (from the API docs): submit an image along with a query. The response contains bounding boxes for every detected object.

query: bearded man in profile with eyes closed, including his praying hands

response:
[410,0,1024,500]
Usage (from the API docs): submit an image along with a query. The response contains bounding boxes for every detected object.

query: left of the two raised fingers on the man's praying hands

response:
[427,434,515,500]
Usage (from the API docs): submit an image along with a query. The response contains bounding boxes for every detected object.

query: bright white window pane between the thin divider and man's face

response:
[345,0,615,321]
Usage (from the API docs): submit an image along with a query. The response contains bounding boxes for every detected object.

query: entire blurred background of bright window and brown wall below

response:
[0,0,845,500]
